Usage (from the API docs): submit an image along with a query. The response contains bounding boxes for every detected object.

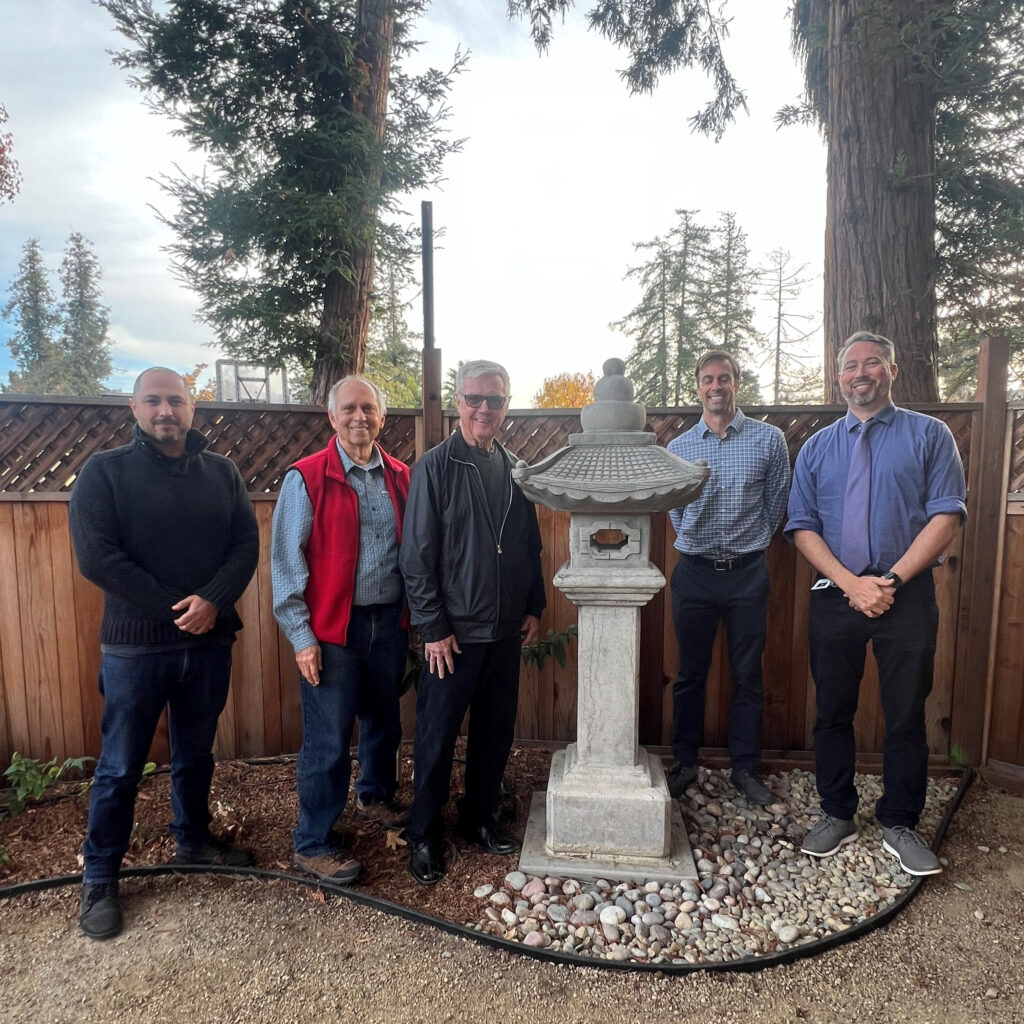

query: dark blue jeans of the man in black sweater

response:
[83,646,231,884]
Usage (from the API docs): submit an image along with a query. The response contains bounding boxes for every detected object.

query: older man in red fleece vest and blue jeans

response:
[270,377,409,885]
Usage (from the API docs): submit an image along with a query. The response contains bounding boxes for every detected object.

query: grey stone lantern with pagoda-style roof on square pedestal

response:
[513,359,709,882]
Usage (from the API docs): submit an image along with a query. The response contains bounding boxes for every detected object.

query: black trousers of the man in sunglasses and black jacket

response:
[406,637,521,843]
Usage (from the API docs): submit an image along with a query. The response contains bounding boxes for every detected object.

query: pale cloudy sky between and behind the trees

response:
[0,0,825,408]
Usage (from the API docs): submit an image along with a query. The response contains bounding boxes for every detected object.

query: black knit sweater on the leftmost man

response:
[70,425,259,644]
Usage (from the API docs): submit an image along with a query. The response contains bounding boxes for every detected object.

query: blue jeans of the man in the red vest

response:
[292,601,409,857]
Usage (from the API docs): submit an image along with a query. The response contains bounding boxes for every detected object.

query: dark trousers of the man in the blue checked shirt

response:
[672,555,768,771]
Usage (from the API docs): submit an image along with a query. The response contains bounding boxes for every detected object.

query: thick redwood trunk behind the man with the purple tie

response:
[824,0,938,402]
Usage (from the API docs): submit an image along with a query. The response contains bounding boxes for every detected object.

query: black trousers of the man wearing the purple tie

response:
[810,570,939,828]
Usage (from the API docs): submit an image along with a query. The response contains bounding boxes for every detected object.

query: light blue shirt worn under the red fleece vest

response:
[270,438,401,650]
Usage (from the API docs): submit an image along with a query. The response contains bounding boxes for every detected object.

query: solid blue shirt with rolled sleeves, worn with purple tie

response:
[785,402,967,572]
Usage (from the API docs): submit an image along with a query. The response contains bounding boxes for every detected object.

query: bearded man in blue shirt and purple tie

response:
[785,331,967,874]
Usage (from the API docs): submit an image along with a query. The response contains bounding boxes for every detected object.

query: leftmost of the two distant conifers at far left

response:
[2,239,59,394]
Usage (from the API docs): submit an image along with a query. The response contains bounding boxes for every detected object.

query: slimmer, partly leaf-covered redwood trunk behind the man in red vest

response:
[309,0,394,404]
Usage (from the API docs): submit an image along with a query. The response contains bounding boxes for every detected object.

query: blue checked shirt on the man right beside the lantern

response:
[668,409,790,558]
